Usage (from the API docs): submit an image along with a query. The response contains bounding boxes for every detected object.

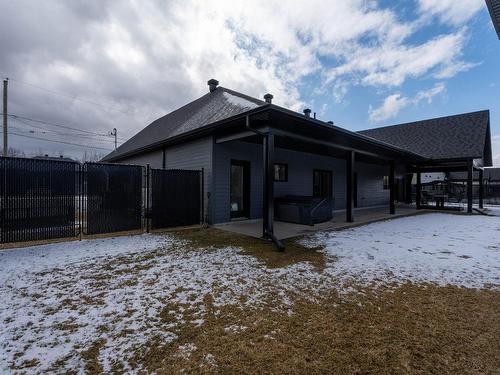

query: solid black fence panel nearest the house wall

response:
[150,169,202,229]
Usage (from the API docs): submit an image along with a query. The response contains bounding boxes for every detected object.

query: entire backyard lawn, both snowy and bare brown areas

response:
[0,213,500,374]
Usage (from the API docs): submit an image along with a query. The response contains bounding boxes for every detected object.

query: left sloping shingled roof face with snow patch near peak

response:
[103,86,267,161]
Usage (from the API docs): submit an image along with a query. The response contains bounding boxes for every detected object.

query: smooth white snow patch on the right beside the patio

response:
[306,213,500,288]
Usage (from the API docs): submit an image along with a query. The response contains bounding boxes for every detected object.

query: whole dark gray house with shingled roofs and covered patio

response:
[103,79,492,244]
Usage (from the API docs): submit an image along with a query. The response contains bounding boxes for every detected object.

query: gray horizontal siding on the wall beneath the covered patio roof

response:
[211,142,389,223]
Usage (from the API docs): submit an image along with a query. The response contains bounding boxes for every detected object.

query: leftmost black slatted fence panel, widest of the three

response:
[0,158,80,243]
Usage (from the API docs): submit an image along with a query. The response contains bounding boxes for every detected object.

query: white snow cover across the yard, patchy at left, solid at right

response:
[0,214,500,373]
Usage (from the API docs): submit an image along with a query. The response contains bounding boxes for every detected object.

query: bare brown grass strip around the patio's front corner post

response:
[170,228,325,271]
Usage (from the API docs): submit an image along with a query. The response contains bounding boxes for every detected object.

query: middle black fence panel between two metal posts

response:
[83,163,144,234]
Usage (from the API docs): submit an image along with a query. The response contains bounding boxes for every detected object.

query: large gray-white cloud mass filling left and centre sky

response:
[0,0,484,160]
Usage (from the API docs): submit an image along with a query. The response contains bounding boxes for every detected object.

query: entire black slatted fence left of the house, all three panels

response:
[0,158,203,243]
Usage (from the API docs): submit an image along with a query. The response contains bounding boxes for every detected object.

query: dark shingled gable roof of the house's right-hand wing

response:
[358,111,491,165]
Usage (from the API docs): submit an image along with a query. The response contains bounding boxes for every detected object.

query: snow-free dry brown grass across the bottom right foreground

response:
[134,284,500,374]
